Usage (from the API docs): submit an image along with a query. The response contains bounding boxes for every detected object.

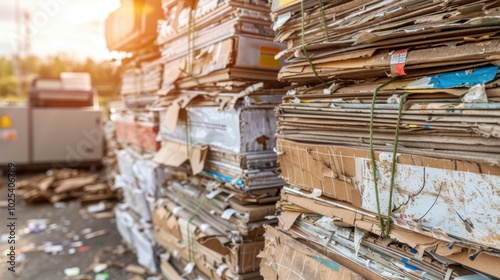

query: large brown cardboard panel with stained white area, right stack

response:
[277,139,500,248]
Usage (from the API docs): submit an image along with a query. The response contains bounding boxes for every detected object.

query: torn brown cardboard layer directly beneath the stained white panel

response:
[281,188,499,279]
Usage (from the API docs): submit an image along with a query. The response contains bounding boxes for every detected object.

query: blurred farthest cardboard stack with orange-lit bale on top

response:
[106,3,168,274]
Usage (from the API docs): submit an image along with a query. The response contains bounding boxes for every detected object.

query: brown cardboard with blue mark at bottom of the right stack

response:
[259,226,363,280]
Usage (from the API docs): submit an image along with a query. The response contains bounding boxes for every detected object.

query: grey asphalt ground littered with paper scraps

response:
[0,173,147,280]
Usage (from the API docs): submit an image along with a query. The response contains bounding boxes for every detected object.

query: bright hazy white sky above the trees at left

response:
[0,0,120,60]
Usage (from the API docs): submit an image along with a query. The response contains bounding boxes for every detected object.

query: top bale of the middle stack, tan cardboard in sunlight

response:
[158,0,283,94]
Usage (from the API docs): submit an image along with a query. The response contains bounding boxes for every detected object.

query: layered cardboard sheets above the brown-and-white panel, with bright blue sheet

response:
[273,1,500,165]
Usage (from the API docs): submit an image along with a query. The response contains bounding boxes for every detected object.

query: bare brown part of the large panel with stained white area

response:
[277,139,500,207]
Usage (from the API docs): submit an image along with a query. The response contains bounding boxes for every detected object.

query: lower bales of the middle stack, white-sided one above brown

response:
[153,86,283,279]
